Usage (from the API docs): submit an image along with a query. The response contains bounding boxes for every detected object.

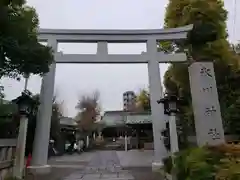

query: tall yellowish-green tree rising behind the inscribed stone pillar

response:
[164,0,240,134]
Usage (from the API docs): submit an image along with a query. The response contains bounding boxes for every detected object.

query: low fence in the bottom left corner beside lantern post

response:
[0,139,17,180]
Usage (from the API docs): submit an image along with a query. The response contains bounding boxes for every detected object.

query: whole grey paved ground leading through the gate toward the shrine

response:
[25,150,163,180]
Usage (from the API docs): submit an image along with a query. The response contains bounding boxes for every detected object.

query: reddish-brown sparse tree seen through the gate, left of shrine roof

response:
[75,91,101,132]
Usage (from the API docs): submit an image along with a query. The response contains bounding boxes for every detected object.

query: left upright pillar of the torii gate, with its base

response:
[28,38,57,174]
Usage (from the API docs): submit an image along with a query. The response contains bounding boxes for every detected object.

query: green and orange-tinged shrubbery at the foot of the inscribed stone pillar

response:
[164,145,240,180]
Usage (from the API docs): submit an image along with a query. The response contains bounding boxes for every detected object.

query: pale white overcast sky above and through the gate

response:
[2,0,240,116]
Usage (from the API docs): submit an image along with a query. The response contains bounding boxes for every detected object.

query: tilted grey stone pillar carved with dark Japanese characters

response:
[189,62,225,146]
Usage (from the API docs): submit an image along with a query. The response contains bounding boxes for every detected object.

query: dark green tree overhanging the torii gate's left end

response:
[0,0,53,79]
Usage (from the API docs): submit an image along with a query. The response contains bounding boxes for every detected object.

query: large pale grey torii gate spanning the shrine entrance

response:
[31,25,193,172]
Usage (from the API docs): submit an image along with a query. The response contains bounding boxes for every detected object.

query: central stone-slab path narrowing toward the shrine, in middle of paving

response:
[63,151,134,180]
